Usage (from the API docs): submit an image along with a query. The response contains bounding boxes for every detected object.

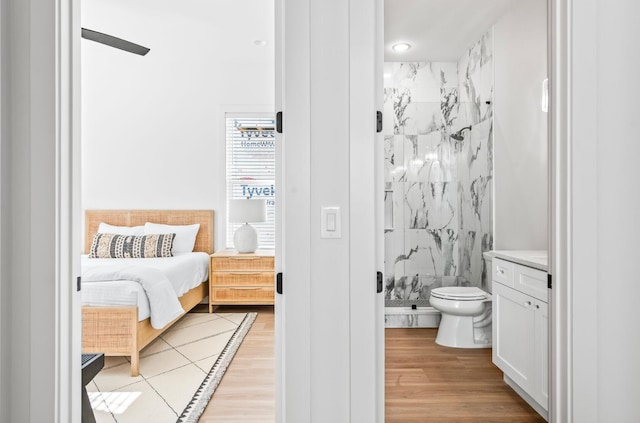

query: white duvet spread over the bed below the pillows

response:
[81,253,209,328]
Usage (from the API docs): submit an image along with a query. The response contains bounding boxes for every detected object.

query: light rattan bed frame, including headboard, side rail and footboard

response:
[82,210,213,376]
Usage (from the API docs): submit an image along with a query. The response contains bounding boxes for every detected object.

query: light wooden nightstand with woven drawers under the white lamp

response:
[209,250,275,313]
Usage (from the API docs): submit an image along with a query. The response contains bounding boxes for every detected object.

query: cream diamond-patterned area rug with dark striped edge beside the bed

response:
[87,313,257,423]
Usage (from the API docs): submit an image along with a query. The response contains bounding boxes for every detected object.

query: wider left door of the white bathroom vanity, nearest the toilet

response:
[492,283,537,392]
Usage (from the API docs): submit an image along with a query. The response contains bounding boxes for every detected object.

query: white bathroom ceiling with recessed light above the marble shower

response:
[384,0,517,62]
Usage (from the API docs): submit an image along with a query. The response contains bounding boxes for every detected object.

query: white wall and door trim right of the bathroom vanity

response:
[550,0,640,423]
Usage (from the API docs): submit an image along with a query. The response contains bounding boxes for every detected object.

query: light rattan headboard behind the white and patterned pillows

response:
[84,210,213,254]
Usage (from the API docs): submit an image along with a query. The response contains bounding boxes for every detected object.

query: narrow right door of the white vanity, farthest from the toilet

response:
[532,301,549,410]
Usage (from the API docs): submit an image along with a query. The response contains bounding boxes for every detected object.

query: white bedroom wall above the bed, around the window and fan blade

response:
[82,0,274,250]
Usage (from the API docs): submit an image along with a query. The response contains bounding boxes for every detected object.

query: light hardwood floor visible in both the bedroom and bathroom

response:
[200,306,544,423]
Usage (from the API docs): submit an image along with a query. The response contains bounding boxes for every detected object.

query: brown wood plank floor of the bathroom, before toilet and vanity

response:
[385,328,545,423]
